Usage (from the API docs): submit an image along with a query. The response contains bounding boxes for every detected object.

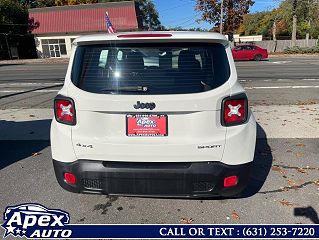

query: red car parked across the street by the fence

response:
[232,44,268,61]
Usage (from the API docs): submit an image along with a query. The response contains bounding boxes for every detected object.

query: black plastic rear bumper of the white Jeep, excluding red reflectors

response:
[53,160,251,197]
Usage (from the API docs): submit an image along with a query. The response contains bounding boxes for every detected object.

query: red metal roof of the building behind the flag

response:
[29,2,138,34]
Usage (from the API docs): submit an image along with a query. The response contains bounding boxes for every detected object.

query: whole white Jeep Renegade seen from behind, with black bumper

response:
[51,32,256,197]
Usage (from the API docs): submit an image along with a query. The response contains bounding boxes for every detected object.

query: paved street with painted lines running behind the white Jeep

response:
[0,57,319,109]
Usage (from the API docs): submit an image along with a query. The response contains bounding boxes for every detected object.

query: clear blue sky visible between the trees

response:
[153,0,280,29]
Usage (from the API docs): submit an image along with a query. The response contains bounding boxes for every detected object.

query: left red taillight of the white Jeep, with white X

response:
[54,97,76,125]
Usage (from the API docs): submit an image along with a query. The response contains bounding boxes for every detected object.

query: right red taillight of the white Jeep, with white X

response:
[221,94,248,126]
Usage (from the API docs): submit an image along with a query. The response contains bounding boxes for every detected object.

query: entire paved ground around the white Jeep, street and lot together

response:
[0,57,319,227]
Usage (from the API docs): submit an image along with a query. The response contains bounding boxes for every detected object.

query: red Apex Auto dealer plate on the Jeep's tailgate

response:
[126,114,168,137]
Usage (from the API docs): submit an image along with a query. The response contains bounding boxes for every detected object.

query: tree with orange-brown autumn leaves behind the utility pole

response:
[195,0,254,33]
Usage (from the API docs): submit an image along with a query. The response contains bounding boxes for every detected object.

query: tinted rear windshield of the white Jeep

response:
[72,43,230,95]
